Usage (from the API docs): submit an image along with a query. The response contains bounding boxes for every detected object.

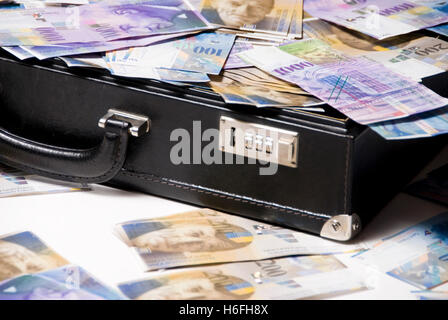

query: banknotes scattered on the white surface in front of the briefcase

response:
[0,209,448,300]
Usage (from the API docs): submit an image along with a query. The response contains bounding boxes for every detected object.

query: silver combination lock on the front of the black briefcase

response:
[219,116,299,168]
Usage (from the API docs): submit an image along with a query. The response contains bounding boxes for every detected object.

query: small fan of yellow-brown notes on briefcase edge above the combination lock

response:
[210,76,323,107]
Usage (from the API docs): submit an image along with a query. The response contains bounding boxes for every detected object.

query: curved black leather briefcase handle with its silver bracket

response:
[0,109,150,183]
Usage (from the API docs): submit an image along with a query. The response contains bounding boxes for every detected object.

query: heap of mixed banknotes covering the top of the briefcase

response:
[0,0,448,139]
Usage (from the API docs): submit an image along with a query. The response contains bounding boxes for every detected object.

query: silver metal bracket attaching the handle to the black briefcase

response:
[98,109,151,137]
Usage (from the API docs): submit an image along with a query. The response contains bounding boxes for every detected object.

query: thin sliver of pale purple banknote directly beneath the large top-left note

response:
[18,32,198,60]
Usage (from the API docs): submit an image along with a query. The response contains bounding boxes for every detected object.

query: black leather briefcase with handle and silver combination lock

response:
[0,50,447,241]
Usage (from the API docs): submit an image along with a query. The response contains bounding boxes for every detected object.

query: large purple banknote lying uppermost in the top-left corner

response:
[0,0,210,46]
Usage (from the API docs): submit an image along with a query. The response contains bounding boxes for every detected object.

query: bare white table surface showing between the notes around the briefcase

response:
[0,147,448,299]
